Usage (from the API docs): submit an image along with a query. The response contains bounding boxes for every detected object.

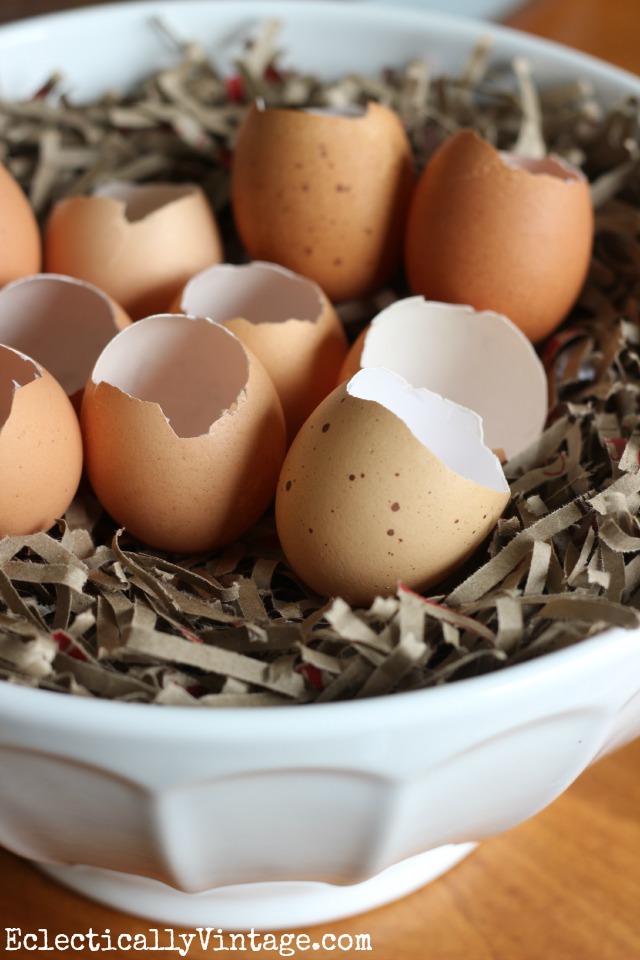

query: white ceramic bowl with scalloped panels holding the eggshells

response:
[0,0,640,929]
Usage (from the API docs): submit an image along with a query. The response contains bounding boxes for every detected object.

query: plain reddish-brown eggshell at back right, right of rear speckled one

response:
[405,130,594,343]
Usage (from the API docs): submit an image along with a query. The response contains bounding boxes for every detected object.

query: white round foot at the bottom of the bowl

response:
[37,843,476,931]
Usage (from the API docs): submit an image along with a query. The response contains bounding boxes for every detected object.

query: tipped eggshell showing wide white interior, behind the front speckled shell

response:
[341,297,548,459]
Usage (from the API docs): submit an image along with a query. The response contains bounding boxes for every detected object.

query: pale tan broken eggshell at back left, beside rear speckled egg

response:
[44,181,223,320]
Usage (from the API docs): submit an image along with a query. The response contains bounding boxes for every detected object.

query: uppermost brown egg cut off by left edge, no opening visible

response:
[0,163,42,286]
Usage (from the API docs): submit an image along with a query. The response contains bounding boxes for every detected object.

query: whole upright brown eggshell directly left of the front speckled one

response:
[81,314,285,553]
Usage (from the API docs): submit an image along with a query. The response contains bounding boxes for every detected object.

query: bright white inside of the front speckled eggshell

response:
[347,367,509,492]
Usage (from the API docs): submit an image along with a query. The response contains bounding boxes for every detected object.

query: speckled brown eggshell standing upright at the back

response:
[231,103,414,302]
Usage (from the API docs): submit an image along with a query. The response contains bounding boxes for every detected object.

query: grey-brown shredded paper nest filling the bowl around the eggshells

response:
[0,16,640,707]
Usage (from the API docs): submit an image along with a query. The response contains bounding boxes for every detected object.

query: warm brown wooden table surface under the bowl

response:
[0,0,640,960]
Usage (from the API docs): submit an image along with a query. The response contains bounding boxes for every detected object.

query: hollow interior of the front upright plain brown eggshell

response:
[92,314,249,437]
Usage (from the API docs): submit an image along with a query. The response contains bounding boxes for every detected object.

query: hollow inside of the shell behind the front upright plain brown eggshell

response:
[180,260,323,324]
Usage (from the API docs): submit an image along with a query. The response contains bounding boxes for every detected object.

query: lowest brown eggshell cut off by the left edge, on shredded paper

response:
[0,345,82,536]
